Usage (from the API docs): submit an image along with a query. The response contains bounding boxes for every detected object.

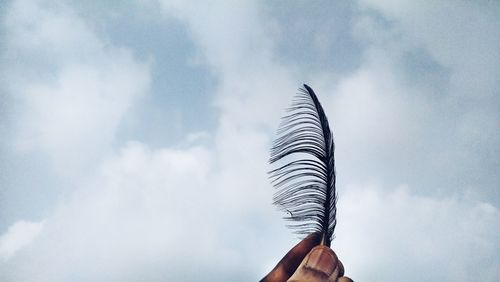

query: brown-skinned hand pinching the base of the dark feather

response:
[261,233,353,282]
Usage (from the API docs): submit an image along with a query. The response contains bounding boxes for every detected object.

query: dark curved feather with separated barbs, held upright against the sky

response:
[269,84,337,246]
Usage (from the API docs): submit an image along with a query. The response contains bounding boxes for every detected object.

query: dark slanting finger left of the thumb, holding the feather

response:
[261,233,321,282]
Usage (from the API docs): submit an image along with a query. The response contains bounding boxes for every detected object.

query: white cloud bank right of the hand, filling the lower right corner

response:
[334,185,500,281]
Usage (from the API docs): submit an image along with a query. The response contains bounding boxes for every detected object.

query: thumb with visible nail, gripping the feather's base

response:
[288,246,343,282]
